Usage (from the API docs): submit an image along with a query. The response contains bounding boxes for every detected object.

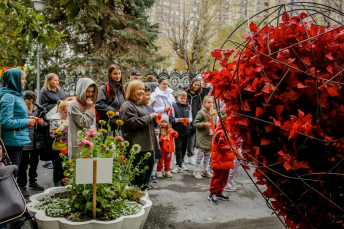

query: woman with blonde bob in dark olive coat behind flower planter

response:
[120,80,160,190]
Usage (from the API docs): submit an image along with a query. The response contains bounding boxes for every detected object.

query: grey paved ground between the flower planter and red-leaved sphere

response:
[30,159,284,229]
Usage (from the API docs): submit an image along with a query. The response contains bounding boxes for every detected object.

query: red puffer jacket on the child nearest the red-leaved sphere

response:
[211,129,235,169]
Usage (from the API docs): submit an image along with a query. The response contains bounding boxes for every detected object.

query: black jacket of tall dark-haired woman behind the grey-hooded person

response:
[95,83,125,130]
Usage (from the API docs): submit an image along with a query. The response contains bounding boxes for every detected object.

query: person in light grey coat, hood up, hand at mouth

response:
[67,78,98,159]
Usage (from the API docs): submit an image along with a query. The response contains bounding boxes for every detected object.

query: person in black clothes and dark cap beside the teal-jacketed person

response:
[17,91,49,196]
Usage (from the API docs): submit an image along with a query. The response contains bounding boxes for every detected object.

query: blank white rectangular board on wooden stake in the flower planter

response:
[75,158,113,184]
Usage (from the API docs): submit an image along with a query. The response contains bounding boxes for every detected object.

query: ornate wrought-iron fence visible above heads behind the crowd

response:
[153,69,202,90]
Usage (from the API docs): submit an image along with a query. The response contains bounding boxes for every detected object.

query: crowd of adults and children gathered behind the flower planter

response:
[0,64,239,204]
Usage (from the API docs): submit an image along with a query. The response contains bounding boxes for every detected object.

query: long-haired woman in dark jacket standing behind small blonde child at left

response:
[39,73,66,169]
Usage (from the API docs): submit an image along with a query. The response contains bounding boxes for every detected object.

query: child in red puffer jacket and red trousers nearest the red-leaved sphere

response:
[208,117,235,204]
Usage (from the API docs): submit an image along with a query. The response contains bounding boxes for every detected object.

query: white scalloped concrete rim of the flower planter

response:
[27,187,152,228]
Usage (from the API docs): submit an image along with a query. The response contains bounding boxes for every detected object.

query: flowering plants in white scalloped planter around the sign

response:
[29,112,152,229]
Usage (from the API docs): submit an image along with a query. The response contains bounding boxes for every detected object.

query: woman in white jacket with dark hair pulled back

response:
[151,76,176,116]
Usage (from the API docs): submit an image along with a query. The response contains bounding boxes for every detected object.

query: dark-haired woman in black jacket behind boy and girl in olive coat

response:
[185,78,202,165]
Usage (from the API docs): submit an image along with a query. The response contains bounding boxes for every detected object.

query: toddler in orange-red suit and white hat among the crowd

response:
[156,114,178,178]
